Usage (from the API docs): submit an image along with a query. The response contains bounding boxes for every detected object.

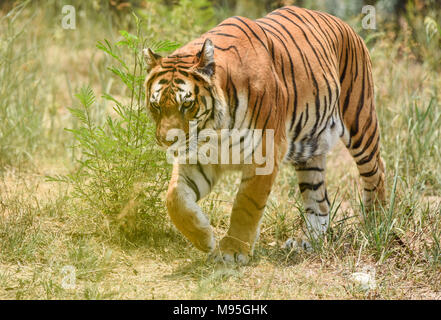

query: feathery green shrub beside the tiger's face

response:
[50,16,177,232]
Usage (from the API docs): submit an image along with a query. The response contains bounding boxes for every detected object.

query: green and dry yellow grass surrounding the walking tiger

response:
[0,0,441,299]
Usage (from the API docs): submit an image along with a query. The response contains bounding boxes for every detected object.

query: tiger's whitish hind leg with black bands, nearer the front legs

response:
[294,155,330,239]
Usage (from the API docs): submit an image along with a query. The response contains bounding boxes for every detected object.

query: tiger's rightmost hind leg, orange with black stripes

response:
[340,36,386,211]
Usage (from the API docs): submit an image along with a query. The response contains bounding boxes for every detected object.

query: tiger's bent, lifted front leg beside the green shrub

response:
[166,164,218,252]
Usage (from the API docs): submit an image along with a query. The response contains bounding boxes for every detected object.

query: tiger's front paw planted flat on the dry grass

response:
[210,236,251,265]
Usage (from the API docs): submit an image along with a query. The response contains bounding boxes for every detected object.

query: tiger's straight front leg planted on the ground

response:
[215,166,277,263]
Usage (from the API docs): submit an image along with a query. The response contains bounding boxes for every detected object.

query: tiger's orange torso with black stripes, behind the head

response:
[175,6,376,162]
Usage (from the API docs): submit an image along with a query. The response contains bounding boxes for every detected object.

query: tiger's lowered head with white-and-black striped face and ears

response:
[144,39,220,147]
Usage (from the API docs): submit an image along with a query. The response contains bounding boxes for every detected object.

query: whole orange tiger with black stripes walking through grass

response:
[143,6,385,264]
